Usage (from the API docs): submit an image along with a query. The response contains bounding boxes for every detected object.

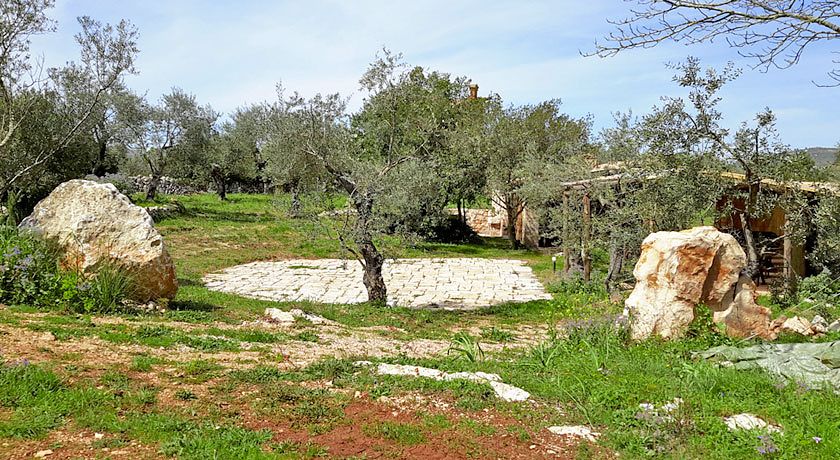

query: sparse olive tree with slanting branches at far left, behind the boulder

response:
[0,0,137,196]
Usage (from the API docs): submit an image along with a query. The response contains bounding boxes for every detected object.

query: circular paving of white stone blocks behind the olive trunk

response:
[204,258,551,310]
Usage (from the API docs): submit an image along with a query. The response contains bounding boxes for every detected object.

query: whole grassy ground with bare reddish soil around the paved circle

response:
[0,194,840,459]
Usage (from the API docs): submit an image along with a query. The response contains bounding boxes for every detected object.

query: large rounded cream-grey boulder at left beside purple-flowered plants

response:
[20,180,178,302]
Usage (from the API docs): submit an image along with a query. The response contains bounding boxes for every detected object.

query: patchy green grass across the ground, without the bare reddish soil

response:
[0,195,840,459]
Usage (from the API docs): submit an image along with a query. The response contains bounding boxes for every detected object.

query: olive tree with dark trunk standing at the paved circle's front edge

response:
[264,51,467,303]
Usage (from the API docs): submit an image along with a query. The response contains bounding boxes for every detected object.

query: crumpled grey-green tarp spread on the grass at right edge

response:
[697,341,840,390]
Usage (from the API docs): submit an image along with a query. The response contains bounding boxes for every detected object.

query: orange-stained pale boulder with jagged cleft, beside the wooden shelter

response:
[625,227,770,340]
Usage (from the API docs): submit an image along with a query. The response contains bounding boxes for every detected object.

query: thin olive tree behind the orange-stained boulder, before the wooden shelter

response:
[642,58,815,277]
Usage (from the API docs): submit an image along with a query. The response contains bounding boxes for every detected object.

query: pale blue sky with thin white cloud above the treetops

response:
[32,0,840,147]
